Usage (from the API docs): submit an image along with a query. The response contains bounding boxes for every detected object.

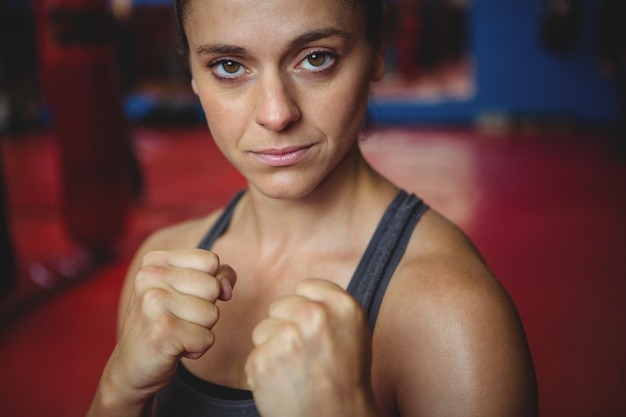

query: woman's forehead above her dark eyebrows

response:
[184,0,365,49]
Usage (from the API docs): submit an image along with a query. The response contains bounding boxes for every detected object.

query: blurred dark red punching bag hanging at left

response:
[36,0,130,250]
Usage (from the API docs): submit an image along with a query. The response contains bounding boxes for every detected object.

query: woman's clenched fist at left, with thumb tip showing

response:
[107,249,236,398]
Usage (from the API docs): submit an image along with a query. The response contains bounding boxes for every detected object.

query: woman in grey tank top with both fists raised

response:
[89,0,537,417]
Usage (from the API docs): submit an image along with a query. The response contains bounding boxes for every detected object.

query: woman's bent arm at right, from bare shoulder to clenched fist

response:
[246,214,537,417]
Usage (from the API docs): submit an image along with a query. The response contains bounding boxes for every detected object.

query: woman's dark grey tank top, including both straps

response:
[154,190,428,417]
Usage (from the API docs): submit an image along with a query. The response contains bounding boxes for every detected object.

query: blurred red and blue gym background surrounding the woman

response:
[0,0,626,417]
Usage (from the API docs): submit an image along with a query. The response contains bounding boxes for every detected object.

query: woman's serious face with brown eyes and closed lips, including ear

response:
[185,0,384,198]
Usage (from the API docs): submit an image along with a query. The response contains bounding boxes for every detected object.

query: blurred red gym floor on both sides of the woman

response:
[0,122,626,417]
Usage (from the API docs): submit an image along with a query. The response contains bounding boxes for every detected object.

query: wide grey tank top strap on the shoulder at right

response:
[347,190,428,332]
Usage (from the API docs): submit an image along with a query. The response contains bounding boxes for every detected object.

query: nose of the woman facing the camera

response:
[255,74,301,132]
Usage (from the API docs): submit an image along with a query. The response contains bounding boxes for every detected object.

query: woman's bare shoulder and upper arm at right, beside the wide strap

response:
[374,210,537,416]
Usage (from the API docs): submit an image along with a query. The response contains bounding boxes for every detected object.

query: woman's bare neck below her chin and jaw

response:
[234,147,397,251]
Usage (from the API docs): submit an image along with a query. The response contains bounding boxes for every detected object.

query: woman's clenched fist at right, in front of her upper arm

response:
[245,280,375,417]
